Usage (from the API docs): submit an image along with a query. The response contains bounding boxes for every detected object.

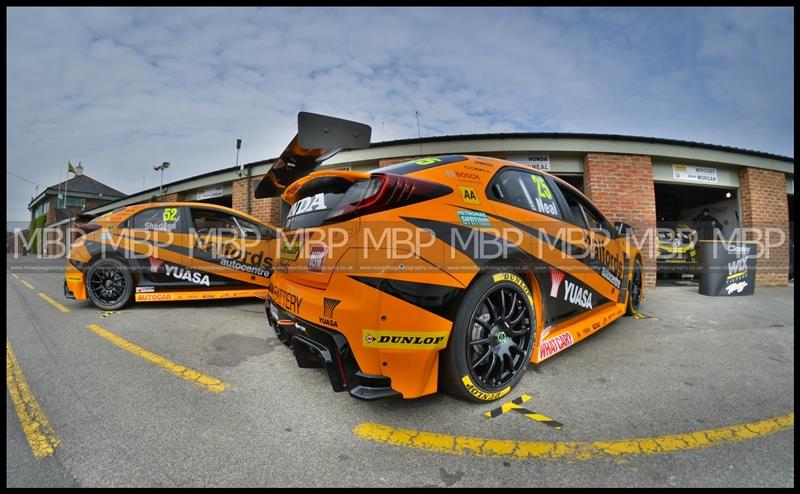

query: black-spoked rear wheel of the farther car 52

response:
[86,258,133,310]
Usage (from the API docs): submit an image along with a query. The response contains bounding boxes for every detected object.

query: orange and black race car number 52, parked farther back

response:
[64,202,276,310]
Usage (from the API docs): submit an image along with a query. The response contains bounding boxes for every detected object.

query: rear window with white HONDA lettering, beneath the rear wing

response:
[283,177,359,230]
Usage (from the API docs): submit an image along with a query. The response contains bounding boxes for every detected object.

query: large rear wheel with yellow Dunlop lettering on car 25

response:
[439,272,536,402]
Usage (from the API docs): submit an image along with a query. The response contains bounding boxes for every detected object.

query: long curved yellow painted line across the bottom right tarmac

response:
[353,412,794,460]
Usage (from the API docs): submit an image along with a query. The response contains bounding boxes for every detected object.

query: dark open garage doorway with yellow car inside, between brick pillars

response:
[654,183,741,286]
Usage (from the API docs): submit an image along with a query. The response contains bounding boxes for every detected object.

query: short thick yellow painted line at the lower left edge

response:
[6,338,61,458]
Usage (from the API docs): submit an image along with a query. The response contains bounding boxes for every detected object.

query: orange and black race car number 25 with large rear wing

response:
[256,113,642,401]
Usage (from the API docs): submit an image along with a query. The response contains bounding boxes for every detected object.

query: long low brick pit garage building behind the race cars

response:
[87,133,794,286]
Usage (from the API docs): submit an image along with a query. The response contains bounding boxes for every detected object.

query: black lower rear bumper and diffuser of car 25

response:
[264,300,400,400]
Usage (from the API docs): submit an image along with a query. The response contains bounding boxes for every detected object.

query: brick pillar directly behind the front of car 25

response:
[583,153,657,287]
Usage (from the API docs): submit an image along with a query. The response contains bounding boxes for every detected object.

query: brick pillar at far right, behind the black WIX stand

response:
[739,168,790,287]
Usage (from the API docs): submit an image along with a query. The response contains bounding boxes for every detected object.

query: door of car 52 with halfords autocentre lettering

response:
[188,207,275,288]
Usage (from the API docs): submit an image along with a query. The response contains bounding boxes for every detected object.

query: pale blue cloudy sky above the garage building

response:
[6,7,794,221]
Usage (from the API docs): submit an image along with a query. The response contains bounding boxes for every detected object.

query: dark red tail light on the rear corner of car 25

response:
[325,173,453,223]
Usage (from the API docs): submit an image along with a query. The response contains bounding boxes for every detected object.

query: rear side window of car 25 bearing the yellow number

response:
[490,169,562,219]
